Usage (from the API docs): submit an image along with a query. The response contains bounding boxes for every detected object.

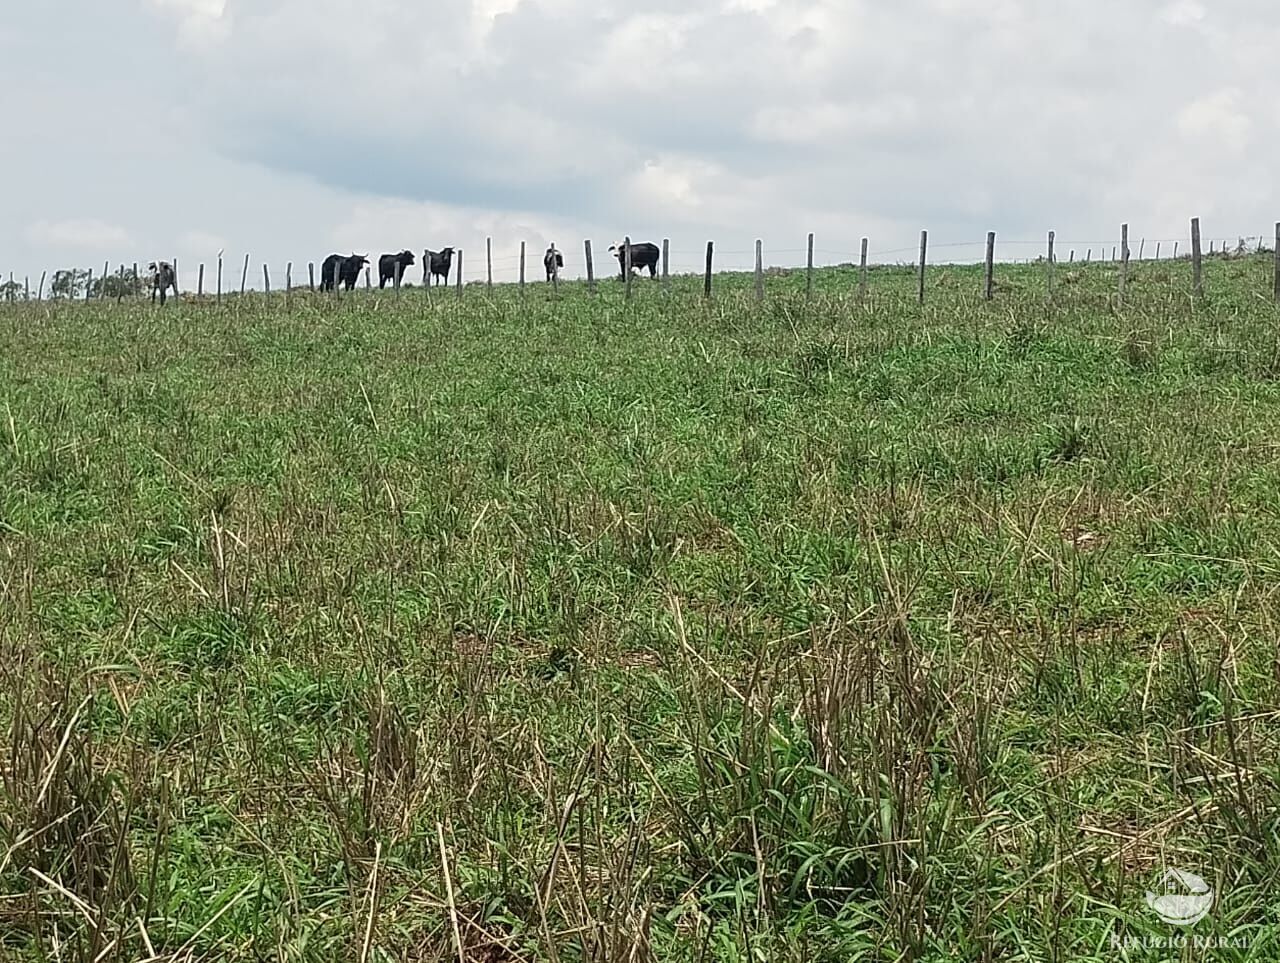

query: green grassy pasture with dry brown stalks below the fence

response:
[0,256,1280,963]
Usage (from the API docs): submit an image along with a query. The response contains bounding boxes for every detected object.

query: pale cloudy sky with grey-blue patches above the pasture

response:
[0,0,1280,284]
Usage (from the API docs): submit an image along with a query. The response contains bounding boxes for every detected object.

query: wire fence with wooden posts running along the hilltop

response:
[0,219,1280,302]
